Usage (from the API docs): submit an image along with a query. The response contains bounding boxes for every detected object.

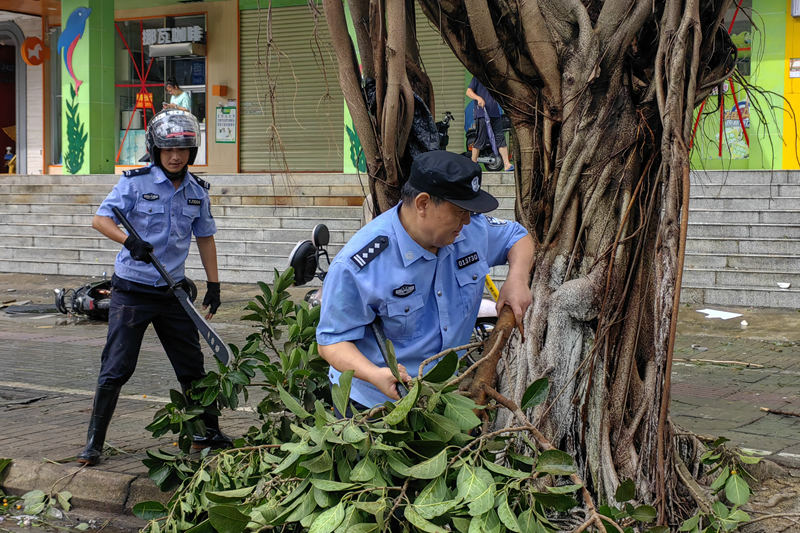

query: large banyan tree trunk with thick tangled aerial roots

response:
[323,0,736,524]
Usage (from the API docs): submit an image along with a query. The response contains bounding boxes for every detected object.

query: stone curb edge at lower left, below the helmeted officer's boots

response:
[2,459,170,514]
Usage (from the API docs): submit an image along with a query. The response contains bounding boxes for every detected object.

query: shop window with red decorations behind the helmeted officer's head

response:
[115,15,206,165]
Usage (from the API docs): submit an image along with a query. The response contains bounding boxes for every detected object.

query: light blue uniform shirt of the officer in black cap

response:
[317,206,527,407]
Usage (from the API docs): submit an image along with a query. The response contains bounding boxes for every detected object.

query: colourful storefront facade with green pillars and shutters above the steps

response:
[0,0,800,174]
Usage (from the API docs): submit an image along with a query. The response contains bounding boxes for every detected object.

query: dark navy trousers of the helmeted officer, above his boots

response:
[97,275,205,387]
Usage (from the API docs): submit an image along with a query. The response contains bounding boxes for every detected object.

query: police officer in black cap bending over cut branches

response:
[317,150,533,409]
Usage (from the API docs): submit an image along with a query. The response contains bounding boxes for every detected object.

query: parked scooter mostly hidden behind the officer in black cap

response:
[289,224,497,341]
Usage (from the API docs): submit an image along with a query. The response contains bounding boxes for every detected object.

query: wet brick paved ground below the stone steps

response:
[0,274,800,528]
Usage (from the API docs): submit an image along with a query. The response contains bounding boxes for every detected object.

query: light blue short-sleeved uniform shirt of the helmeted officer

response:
[97,166,217,286]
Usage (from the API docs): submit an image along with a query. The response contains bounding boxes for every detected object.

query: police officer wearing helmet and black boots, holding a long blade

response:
[78,110,231,465]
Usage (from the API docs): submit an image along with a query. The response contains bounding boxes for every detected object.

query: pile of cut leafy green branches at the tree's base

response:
[134,270,680,533]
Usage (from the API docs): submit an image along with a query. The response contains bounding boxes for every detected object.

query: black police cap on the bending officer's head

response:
[408,150,500,213]
